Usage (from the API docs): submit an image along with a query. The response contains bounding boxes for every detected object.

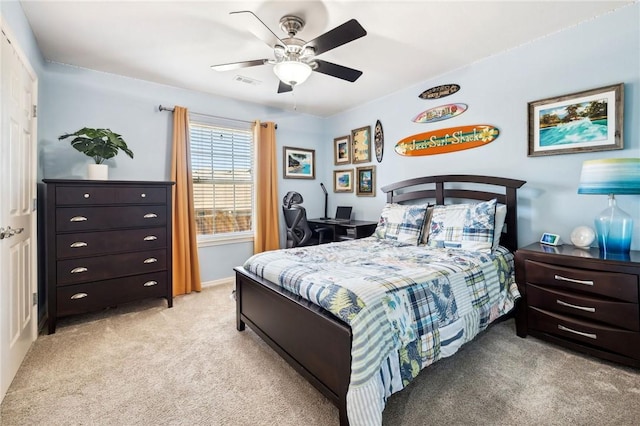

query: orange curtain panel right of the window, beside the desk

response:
[253,121,280,253]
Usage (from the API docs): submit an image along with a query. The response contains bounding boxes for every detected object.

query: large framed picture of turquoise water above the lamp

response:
[528,83,624,157]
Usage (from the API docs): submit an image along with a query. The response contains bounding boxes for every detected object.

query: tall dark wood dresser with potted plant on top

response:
[40,179,173,334]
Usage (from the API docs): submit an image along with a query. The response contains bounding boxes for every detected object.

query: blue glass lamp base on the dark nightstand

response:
[595,194,633,254]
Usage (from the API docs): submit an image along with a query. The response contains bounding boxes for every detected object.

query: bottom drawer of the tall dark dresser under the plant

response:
[57,272,168,316]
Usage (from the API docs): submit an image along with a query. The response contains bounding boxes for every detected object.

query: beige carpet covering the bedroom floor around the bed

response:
[0,285,640,426]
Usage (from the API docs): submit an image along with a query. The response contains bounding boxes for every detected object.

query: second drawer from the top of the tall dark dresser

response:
[56,205,167,232]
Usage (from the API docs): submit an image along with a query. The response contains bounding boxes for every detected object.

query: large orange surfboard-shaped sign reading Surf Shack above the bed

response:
[395,124,500,157]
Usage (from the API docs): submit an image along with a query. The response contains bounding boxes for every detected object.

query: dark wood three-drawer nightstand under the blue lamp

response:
[516,243,640,368]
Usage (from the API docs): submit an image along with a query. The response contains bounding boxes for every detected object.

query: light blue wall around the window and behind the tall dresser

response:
[38,63,324,281]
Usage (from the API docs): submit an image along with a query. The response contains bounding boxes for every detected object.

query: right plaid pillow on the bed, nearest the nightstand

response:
[428,199,496,253]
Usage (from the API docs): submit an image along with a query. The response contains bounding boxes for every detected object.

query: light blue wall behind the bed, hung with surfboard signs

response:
[326,3,640,250]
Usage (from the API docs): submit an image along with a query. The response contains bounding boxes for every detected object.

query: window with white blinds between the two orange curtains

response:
[189,119,254,241]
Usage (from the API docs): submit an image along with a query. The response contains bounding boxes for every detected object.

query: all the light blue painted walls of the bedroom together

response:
[5,1,640,281]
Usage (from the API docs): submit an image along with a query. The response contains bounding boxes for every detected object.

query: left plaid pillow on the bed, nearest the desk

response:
[374,203,428,245]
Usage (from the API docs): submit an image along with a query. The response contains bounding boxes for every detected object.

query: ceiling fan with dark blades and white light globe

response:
[211,10,367,93]
